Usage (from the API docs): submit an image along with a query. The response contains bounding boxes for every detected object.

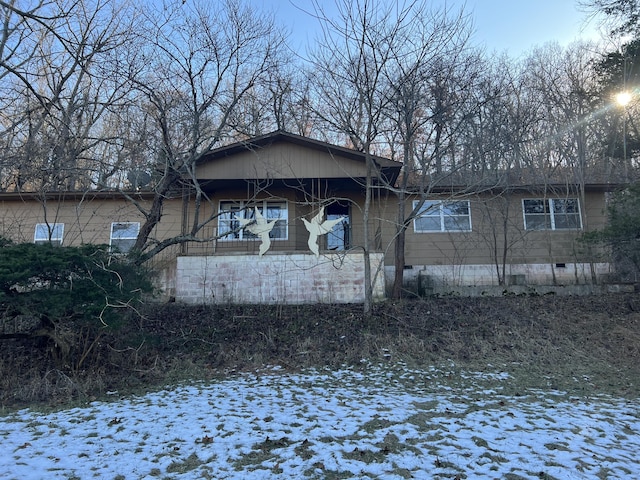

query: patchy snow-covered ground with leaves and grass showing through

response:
[0,366,640,480]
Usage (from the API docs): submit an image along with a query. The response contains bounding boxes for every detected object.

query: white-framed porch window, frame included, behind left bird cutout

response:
[218,199,289,242]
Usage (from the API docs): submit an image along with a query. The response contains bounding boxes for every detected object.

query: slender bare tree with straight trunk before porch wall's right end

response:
[311,0,417,314]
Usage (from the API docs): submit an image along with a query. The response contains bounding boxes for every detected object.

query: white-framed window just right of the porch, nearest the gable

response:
[413,200,471,233]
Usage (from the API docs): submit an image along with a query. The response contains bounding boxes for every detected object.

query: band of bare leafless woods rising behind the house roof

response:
[0,0,639,191]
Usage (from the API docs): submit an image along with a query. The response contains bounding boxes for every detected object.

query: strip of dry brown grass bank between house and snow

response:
[0,294,640,407]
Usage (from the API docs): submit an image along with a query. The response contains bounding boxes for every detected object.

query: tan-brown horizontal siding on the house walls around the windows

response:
[0,188,606,265]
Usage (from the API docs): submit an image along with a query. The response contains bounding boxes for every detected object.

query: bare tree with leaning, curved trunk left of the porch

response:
[122,0,284,262]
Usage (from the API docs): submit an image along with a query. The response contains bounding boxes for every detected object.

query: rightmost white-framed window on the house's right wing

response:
[522,198,582,230]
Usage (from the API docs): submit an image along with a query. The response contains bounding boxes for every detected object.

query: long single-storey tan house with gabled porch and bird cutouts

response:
[0,132,611,303]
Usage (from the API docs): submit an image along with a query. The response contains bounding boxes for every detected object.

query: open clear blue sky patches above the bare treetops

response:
[251,0,599,56]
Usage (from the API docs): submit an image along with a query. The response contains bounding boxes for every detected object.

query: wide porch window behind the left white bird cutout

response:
[218,200,288,240]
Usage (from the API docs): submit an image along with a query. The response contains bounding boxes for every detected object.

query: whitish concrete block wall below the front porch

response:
[175,253,384,304]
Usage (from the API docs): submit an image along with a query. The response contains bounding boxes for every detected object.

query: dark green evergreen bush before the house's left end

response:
[0,239,152,369]
